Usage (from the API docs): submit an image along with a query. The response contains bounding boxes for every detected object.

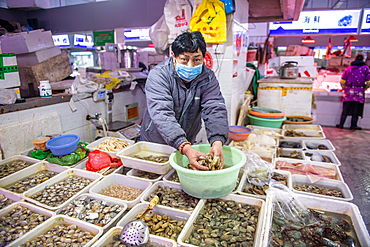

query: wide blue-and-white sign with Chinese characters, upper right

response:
[270,9,361,35]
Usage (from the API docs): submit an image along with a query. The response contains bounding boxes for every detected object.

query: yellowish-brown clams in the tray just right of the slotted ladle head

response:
[139,212,186,241]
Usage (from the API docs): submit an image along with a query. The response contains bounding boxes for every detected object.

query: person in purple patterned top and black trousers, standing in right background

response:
[337,54,370,130]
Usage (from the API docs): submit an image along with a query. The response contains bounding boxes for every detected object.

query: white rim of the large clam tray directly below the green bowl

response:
[177,194,265,247]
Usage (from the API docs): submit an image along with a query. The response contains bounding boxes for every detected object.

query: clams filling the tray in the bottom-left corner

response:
[0,206,49,246]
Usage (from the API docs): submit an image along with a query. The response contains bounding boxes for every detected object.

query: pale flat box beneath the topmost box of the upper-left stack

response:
[17,46,61,66]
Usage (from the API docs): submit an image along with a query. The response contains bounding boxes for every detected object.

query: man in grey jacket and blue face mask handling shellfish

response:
[141,32,229,170]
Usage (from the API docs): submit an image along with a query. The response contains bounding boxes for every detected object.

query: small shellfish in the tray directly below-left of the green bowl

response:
[147,185,199,211]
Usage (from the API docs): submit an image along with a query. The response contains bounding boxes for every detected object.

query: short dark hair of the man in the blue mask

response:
[172,31,206,57]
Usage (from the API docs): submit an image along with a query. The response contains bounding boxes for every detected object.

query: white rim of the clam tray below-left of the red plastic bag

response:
[22,169,102,211]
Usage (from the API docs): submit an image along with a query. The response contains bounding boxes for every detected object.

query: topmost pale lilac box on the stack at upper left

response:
[0,30,54,54]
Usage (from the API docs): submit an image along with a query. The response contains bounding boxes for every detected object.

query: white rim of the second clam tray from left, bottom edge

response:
[12,215,103,247]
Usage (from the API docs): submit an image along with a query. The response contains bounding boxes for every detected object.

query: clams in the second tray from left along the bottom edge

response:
[21,224,95,247]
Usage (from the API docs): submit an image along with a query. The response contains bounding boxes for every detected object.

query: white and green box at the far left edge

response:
[0,53,21,88]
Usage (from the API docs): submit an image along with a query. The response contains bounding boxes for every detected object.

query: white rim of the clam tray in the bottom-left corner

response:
[0,202,55,246]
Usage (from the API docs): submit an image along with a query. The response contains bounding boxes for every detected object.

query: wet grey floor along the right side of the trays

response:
[323,127,370,231]
